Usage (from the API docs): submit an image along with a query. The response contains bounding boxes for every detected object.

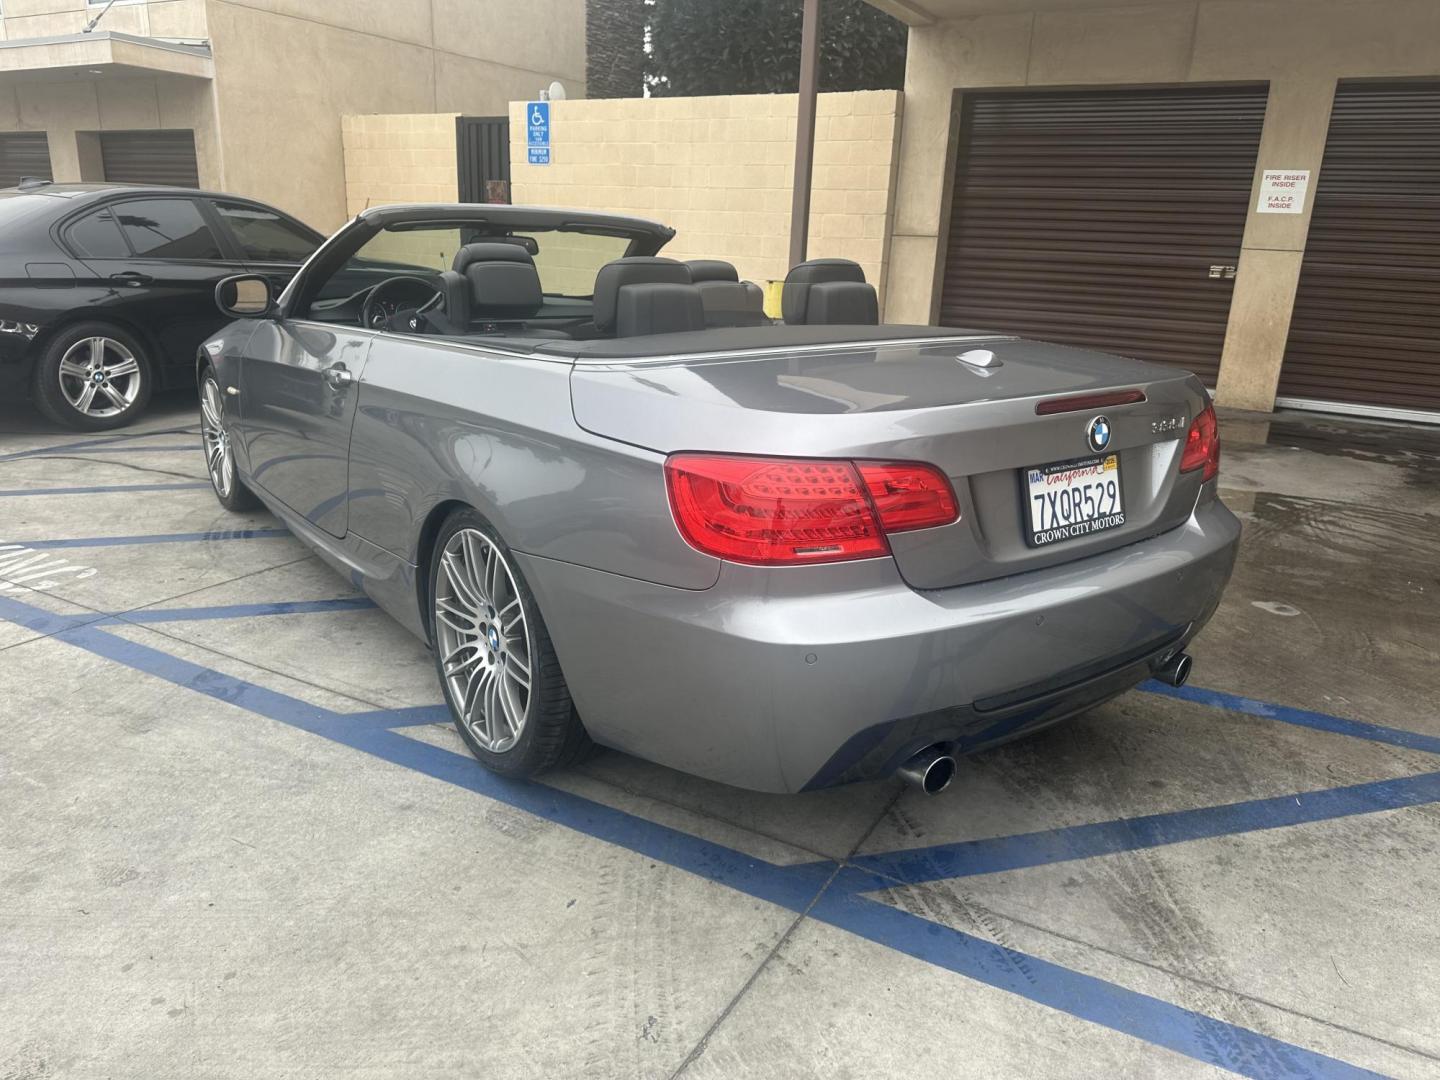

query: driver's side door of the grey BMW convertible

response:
[235,318,374,537]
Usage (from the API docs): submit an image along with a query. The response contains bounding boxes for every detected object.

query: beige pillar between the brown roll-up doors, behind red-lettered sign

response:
[1215,76,1335,412]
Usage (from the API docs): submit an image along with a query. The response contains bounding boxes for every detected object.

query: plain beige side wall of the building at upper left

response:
[207,0,585,229]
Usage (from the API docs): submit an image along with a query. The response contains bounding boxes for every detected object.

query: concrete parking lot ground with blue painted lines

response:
[0,397,1440,1080]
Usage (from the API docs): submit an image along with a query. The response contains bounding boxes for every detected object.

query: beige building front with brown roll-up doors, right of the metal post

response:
[871,0,1440,420]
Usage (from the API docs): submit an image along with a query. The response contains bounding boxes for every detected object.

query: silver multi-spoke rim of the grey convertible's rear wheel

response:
[435,528,531,753]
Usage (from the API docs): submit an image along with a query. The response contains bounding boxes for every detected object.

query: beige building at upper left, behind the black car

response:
[0,0,585,230]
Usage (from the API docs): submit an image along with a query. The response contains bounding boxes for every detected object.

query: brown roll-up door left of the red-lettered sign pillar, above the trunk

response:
[940,86,1267,386]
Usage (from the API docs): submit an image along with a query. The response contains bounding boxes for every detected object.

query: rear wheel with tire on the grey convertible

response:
[429,510,593,776]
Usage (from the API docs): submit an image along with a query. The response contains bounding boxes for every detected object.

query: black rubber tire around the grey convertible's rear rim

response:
[425,510,578,778]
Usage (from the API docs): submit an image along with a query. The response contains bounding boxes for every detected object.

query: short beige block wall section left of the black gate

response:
[340,112,459,216]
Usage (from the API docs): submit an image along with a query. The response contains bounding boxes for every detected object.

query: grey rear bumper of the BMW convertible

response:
[520,500,1240,792]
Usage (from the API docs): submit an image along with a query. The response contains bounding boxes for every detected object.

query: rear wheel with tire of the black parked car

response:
[33,323,154,431]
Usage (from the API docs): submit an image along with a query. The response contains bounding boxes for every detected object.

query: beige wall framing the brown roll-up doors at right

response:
[886,0,1440,409]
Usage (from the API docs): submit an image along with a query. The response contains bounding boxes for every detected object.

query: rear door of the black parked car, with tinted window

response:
[66,194,242,366]
